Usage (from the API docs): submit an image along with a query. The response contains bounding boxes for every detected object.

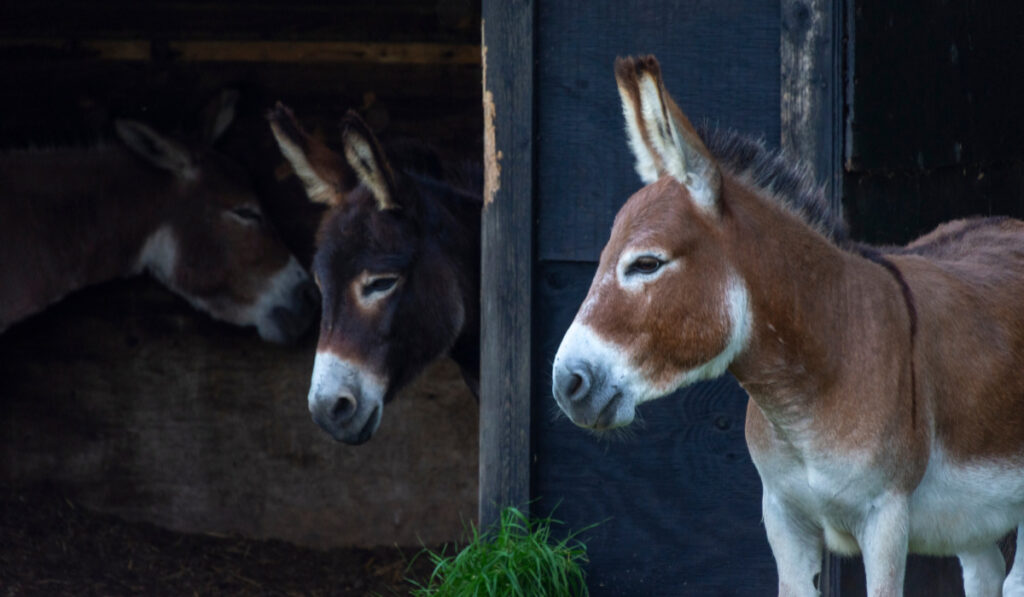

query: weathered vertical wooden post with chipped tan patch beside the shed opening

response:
[479,0,535,526]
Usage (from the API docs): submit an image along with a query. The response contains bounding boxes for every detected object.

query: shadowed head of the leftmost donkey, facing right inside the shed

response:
[116,94,317,342]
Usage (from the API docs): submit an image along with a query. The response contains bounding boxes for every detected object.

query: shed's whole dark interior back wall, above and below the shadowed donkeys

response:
[0,0,481,546]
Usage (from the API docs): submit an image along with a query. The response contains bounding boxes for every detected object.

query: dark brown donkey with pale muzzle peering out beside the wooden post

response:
[268,102,482,444]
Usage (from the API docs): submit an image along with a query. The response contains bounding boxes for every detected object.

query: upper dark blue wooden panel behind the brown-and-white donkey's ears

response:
[537,0,779,261]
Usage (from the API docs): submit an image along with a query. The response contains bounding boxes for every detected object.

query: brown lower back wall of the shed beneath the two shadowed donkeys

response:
[0,279,477,547]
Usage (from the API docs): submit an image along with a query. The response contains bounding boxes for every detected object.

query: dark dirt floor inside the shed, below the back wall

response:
[0,485,431,597]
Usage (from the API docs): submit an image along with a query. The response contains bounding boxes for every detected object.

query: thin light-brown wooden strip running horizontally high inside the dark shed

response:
[0,39,480,65]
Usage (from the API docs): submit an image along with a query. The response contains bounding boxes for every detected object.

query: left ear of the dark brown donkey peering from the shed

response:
[266,101,356,206]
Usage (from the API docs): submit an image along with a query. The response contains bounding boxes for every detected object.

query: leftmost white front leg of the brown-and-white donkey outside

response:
[761,492,823,597]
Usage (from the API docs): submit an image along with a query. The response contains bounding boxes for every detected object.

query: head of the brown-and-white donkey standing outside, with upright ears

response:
[553,56,751,429]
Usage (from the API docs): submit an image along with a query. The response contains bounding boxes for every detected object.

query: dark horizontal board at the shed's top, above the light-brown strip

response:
[0,0,480,43]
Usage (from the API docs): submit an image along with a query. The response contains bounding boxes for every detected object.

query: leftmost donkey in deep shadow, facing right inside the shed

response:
[0,94,317,342]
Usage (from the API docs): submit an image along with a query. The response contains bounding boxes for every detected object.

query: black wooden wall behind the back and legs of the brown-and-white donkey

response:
[841,0,1024,597]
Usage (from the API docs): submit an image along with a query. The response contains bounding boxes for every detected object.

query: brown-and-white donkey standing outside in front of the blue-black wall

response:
[553,56,1024,596]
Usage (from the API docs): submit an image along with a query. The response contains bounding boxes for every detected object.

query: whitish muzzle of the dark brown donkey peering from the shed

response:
[309,351,387,445]
